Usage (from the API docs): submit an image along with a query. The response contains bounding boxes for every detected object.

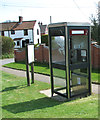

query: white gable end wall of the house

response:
[34,21,41,44]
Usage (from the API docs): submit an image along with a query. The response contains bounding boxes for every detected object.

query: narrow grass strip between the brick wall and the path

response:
[4,62,100,83]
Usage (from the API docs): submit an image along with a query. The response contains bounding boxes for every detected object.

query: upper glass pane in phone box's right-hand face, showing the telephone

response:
[70,35,88,64]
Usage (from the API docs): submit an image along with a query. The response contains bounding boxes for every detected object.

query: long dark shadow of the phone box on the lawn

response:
[2,97,63,114]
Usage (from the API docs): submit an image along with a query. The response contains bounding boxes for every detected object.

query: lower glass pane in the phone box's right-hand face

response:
[70,69,88,96]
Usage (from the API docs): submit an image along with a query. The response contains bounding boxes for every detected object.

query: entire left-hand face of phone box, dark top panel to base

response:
[49,27,66,96]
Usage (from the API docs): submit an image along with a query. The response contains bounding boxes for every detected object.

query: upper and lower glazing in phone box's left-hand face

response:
[51,36,66,94]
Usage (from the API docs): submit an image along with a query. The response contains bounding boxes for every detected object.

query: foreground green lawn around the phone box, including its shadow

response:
[2,72,98,118]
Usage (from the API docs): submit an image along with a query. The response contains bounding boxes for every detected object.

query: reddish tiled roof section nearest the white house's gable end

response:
[13,21,36,30]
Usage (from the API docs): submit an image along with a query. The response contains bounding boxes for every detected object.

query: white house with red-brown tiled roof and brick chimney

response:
[0,16,41,48]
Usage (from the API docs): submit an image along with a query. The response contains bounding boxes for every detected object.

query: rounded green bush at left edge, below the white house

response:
[0,36,14,55]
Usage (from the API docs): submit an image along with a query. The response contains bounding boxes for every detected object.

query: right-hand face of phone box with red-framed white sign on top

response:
[69,29,90,97]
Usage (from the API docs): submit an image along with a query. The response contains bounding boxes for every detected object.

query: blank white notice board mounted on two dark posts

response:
[28,45,34,64]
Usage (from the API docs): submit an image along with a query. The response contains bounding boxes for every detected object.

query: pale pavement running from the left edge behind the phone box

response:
[0,59,100,94]
